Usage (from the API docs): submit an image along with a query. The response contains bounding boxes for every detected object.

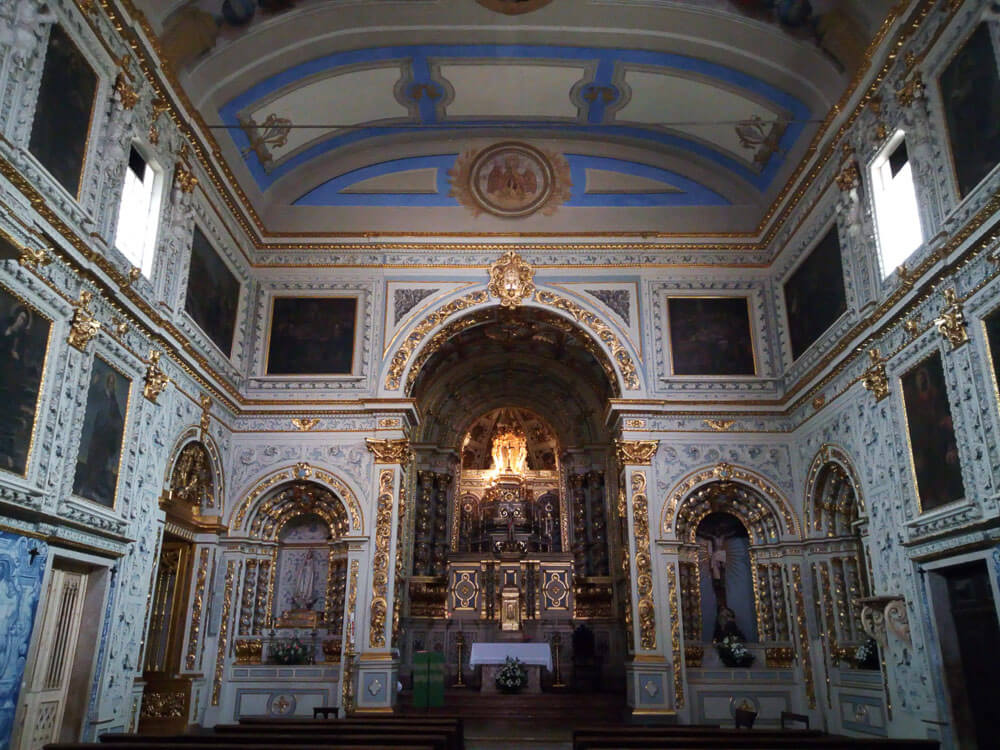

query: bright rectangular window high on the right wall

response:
[871,130,923,278]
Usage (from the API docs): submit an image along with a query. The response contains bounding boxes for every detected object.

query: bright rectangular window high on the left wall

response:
[115,146,163,278]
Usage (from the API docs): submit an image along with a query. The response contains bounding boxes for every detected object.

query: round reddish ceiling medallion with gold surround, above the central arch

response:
[448,142,572,219]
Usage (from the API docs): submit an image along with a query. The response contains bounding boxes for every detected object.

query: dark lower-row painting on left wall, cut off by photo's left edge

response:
[0,287,52,476]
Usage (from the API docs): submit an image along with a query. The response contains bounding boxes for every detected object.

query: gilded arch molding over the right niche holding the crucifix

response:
[660,463,802,544]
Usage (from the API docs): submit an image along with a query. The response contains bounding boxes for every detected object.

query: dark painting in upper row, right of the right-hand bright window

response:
[938,23,1000,196]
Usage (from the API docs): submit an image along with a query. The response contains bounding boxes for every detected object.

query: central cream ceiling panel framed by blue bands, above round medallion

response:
[439,62,586,119]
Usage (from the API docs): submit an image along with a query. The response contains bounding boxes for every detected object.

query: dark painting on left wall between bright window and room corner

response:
[184,226,240,357]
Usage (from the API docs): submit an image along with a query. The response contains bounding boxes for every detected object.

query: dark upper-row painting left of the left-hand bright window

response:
[28,24,97,196]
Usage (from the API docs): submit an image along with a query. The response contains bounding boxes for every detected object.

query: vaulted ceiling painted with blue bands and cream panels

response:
[135,0,900,235]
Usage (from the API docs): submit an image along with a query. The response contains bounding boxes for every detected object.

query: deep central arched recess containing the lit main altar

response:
[400,308,625,690]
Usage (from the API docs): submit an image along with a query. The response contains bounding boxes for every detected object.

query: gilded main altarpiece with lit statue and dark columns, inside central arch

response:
[404,409,617,691]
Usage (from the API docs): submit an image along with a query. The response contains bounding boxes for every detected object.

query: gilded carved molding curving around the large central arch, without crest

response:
[384,289,641,394]
